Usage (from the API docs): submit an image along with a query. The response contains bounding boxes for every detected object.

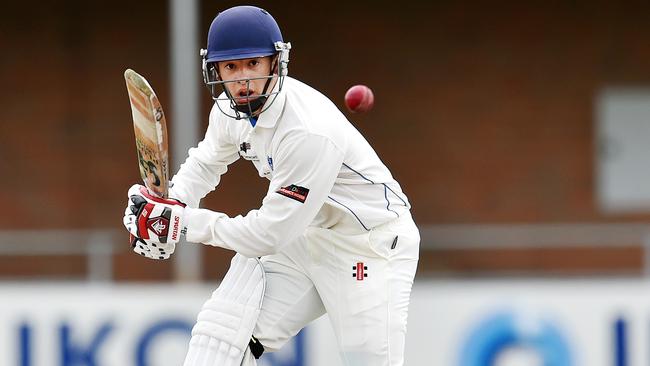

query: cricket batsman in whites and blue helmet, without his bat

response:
[124,6,420,366]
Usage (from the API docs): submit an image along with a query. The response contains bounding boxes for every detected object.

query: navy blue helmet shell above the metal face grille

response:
[206,6,284,62]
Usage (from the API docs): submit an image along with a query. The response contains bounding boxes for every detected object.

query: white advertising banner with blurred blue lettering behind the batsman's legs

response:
[0,279,650,366]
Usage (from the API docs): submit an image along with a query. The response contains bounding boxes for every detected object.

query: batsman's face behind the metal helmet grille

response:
[218,56,277,104]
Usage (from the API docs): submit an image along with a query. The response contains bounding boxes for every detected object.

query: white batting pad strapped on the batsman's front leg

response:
[183,254,266,366]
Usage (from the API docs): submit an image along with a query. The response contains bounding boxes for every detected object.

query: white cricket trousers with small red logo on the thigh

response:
[253,212,420,366]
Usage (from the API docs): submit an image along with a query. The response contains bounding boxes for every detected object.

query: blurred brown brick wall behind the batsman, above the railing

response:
[0,0,650,278]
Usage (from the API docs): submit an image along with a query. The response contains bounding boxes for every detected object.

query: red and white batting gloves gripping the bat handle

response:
[123,184,185,259]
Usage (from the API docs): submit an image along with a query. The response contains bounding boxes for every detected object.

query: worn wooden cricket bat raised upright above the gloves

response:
[124,69,169,198]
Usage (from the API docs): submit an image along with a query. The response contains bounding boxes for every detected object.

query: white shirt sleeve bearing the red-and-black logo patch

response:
[185,133,344,257]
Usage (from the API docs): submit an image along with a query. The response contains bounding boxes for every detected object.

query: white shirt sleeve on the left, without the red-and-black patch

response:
[169,110,239,207]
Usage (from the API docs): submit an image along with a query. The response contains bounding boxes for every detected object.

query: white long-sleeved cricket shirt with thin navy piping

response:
[170,77,410,257]
